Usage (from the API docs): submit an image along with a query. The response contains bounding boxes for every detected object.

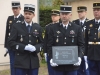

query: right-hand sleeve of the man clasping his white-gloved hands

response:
[35,27,43,53]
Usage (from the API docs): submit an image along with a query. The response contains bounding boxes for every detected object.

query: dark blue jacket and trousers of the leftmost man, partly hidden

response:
[4,14,24,75]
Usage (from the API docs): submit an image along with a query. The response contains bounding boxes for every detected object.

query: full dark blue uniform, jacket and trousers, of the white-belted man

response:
[85,19,100,75]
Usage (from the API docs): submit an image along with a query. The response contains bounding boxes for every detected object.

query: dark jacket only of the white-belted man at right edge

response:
[85,19,100,61]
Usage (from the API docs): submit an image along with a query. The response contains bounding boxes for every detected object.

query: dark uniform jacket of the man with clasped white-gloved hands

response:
[8,22,43,69]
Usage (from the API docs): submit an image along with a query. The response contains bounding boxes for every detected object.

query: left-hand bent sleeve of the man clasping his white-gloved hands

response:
[8,25,25,52]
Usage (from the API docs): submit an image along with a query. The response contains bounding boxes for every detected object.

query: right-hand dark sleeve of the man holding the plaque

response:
[78,27,85,57]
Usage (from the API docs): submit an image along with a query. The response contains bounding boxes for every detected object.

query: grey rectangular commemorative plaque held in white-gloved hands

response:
[52,46,78,65]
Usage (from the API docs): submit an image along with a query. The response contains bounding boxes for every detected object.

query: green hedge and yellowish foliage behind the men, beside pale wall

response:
[39,0,64,63]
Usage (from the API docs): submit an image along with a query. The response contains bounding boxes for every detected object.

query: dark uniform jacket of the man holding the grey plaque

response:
[47,22,84,71]
